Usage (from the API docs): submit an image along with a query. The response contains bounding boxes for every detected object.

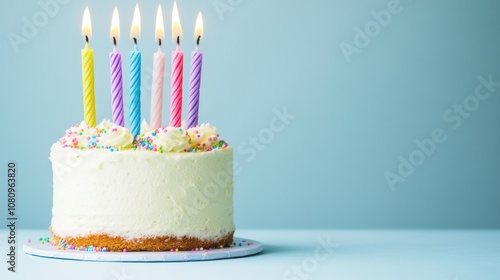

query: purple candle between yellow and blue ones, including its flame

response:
[109,7,124,126]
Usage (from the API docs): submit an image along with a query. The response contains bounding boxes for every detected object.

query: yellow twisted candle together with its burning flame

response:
[82,7,96,126]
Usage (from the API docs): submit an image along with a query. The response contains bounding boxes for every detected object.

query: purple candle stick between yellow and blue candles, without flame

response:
[109,52,125,127]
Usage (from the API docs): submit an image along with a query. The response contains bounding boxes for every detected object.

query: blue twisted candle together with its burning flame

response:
[129,4,141,138]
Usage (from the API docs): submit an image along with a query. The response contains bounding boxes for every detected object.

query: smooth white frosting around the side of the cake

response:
[50,144,235,240]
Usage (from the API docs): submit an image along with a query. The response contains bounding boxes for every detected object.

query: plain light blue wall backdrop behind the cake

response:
[0,0,500,228]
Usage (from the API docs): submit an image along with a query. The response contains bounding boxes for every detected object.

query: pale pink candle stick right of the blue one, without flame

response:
[149,50,165,129]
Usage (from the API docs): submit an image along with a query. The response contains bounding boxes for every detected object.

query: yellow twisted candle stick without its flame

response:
[82,43,96,127]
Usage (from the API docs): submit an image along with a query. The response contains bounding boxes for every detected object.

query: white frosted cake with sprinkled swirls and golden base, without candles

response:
[50,121,235,251]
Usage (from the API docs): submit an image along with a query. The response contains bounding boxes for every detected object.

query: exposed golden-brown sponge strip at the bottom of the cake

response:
[51,230,234,252]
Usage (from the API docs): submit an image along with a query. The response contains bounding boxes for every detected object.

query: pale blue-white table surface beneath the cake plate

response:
[0,230,500,280]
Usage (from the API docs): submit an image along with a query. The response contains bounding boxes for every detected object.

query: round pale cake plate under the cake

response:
[23,237,264,262]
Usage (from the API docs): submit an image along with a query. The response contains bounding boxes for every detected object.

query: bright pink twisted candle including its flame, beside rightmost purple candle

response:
[170,1,184,127]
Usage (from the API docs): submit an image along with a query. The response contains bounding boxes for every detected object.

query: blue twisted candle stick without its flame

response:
[129,46,141,139]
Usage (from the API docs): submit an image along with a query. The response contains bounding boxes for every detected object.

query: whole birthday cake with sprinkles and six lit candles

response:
[44,2,235,251]
